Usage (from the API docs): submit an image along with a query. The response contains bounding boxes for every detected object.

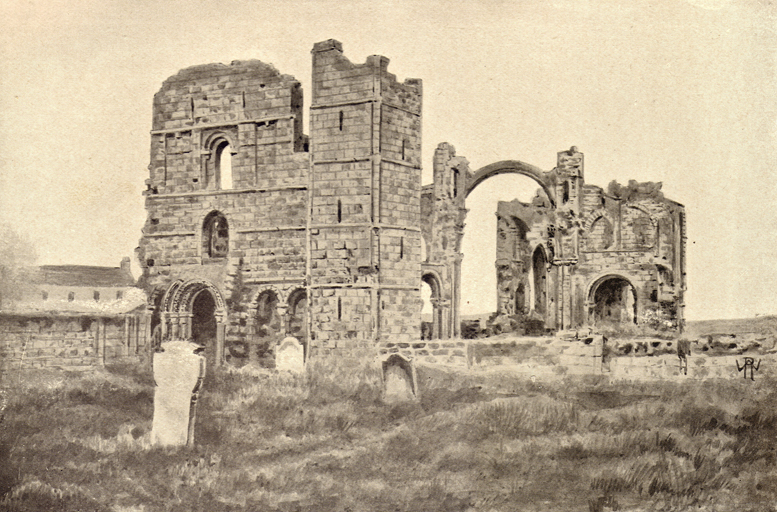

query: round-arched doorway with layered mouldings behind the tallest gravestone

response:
[160,280,227,366]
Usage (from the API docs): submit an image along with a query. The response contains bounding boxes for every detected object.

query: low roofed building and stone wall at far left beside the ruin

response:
[0,258,151,370]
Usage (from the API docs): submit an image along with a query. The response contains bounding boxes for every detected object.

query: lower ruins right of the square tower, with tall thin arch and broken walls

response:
[422,144,685,337]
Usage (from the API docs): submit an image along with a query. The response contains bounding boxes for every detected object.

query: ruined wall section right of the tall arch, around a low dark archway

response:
[576,181,686,331]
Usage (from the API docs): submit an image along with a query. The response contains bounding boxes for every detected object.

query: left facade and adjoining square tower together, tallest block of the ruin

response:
[138,40,421,364]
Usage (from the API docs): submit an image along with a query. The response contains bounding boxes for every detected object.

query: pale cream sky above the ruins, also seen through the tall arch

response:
[0,0,777,319]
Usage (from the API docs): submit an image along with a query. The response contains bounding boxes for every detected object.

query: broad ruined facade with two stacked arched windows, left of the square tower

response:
[139,61,309,364]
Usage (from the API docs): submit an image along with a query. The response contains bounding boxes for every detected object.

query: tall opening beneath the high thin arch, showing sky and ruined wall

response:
[461,174,550,337]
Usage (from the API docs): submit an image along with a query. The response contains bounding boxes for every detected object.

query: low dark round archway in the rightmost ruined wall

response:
[588,275,637,328]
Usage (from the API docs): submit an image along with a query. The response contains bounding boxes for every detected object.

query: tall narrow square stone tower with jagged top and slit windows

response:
[310,40,421,356]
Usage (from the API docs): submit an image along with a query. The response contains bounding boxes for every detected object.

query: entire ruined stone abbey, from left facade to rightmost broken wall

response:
[138,40,686,364]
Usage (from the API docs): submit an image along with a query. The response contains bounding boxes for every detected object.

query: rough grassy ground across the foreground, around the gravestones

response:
[0,365,777,512]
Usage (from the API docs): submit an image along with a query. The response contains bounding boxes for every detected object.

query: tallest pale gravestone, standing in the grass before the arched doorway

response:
[151,341,205,446]
